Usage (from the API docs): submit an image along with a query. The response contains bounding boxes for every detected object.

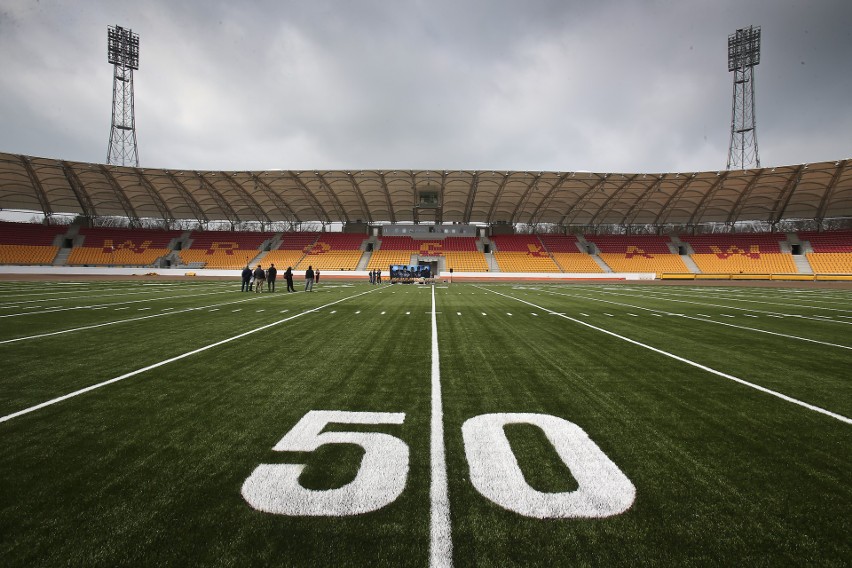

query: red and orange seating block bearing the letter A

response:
[585,235,691,274]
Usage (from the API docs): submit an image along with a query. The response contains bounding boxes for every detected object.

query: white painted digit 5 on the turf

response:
[242,410,408,517]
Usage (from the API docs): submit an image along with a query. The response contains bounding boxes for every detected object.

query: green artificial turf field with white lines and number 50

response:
[0,280,852,566]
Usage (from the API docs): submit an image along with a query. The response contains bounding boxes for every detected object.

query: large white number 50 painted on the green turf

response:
[242,410,636,519]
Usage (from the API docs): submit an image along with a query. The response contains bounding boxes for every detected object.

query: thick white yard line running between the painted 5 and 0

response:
[429,286,453,568]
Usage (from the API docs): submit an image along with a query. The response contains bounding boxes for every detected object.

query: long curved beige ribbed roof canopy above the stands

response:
[0,153,852,230]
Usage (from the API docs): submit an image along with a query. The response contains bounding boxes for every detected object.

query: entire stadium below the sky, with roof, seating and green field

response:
[0,4,852,566]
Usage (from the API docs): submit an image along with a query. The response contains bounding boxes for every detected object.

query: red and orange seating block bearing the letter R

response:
[180,231,274,270]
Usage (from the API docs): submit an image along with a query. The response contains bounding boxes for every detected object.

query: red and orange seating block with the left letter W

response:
[66,227,181,266]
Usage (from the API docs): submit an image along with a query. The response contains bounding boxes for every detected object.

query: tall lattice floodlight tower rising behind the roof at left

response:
[107,26,139,167]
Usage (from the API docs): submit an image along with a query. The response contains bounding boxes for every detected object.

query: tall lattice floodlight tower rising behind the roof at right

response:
[728,26,760,170]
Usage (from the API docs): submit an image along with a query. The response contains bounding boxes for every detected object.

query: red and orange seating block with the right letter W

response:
[680,233,798,274]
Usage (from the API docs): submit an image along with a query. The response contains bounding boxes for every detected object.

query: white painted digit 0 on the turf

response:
[462,414,636,519]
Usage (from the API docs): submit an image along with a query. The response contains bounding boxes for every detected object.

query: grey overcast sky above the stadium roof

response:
[0,0,852,172]
